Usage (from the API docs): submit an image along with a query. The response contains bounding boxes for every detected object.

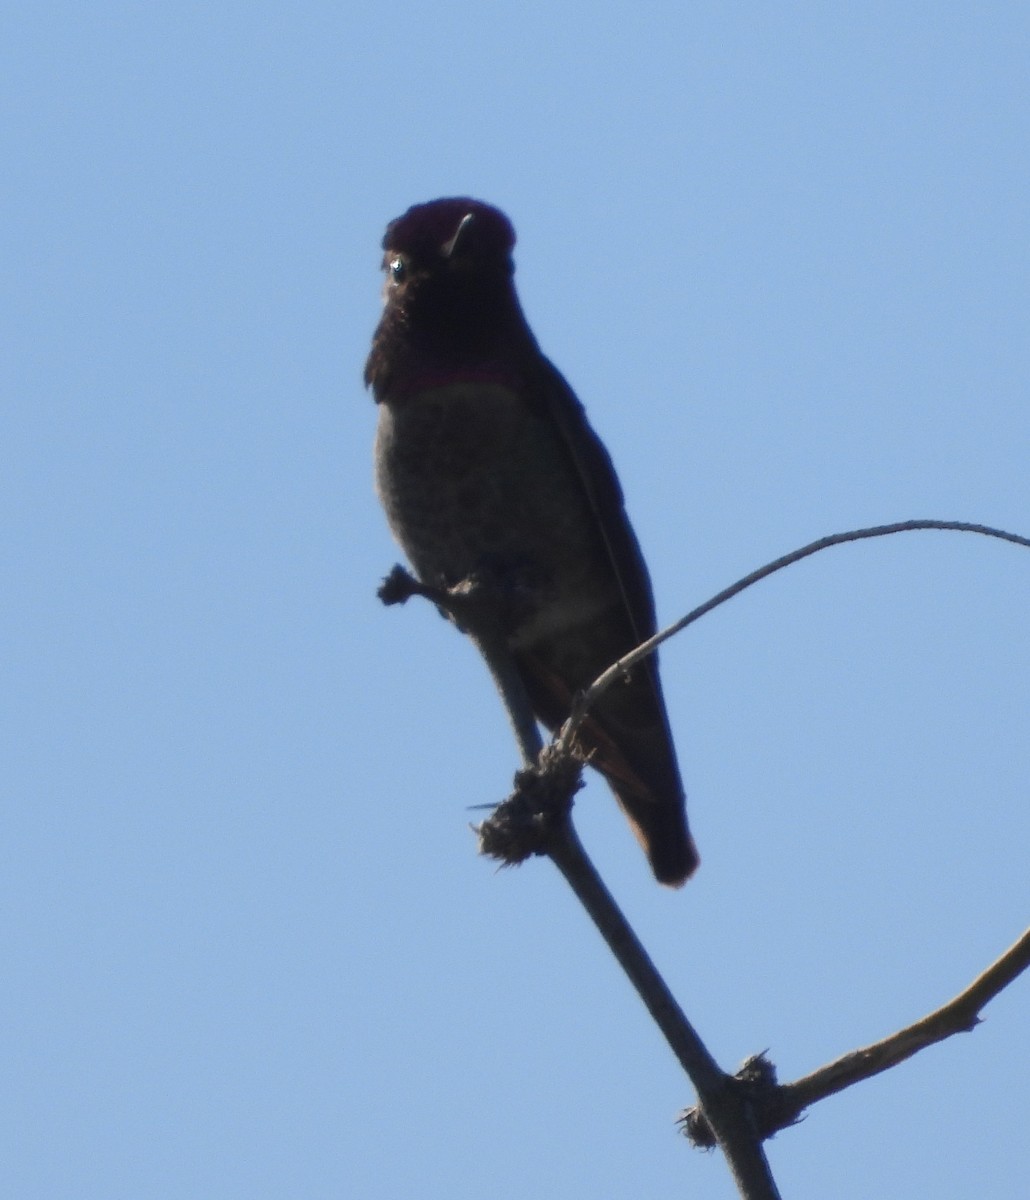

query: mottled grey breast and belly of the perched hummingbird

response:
[376,382,618,642]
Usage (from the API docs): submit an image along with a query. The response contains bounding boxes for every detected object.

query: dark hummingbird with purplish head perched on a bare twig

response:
[365,198,697,886]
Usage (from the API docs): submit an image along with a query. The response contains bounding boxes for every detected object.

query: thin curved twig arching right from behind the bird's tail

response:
[557,521,1030,746]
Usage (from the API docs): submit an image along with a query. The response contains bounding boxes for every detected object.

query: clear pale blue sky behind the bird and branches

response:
[0,0,1030,1200]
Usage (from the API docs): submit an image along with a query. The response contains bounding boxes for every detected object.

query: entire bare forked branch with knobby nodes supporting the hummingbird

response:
[379,521,1030,1200]
